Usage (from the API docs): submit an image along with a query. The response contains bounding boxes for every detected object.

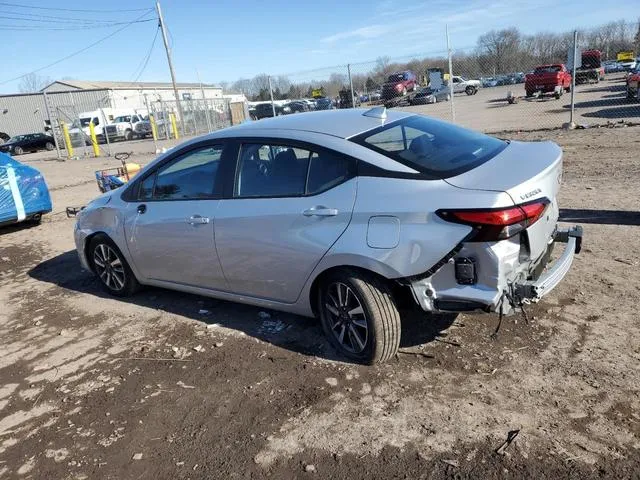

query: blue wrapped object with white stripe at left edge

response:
[0,152,51,224]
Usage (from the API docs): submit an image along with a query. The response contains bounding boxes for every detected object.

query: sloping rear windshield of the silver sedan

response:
[352,116,507,179]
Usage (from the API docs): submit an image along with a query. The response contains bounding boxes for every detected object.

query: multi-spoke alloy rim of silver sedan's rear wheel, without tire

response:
[324,282,369,354]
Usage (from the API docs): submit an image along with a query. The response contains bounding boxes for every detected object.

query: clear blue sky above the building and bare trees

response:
[0,0,638,93]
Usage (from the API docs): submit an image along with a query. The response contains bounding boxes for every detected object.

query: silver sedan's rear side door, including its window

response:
[215,141,356,303]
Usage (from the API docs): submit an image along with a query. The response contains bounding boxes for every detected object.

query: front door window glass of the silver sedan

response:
[138,145,223,200]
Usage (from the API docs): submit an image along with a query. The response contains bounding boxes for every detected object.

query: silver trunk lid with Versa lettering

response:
[446,141,562,260]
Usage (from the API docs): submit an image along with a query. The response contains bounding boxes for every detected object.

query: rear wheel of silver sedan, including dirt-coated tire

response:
[318,269,401,365]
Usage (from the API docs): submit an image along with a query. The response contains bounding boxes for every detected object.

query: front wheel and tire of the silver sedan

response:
[87,234,140,297]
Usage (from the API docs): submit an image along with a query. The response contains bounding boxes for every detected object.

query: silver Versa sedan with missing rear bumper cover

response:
[74,107,582,363]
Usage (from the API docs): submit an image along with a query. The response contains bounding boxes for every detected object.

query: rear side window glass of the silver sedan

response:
[234,144,355,198]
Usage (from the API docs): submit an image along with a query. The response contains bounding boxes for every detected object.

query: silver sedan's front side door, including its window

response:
[125,145,226,289]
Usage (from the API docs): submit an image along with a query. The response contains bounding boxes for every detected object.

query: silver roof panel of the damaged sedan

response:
[212,108,414,138]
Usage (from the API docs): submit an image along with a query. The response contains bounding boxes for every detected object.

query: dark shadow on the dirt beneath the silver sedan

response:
[28,250,456,361]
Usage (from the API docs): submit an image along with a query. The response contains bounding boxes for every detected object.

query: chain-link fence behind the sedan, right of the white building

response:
[245,22,640,133]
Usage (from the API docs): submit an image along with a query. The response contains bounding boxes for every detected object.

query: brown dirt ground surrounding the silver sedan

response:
[0,127,640,479]
